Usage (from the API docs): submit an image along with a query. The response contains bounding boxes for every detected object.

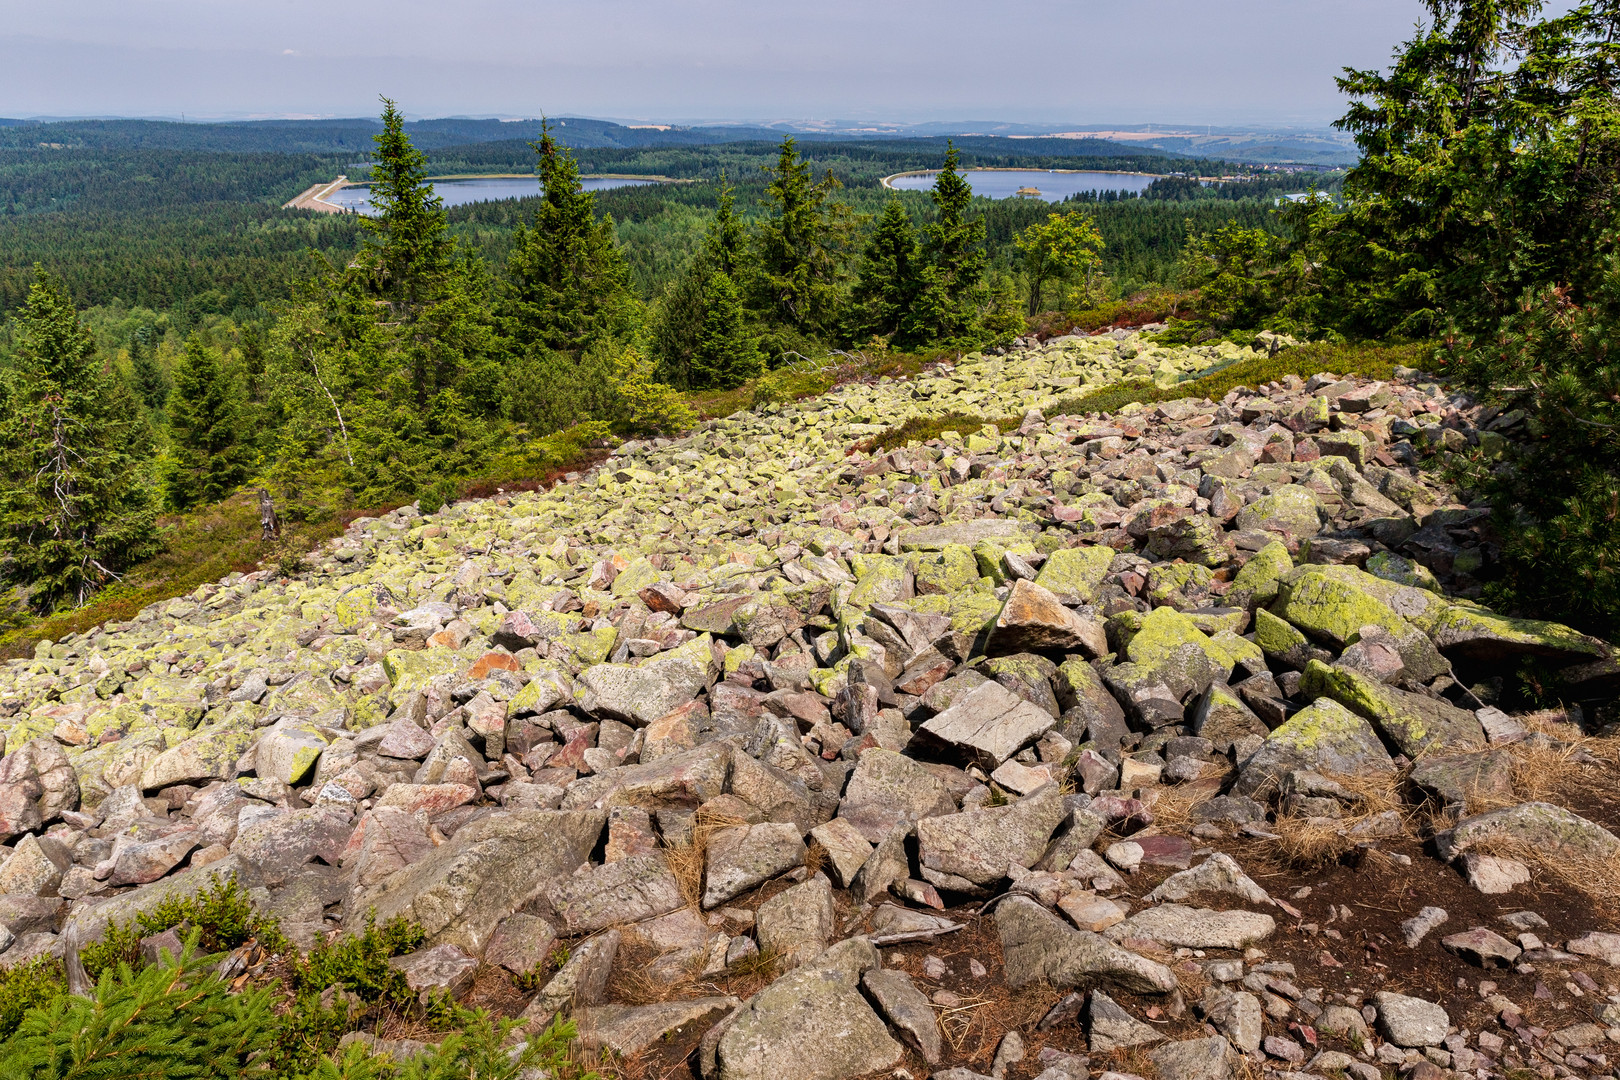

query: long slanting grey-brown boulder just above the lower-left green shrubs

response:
[343,810,608,955]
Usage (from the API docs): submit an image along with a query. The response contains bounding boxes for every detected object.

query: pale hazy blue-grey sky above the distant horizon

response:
[0,0,1422,125]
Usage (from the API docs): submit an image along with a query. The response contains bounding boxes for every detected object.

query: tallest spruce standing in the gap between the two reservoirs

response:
[750,136,851,337]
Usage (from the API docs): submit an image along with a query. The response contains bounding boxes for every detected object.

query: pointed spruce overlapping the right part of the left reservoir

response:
[505,125,635,353]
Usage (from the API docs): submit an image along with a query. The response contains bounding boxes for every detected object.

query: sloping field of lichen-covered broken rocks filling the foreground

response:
[0,334,1620,1080]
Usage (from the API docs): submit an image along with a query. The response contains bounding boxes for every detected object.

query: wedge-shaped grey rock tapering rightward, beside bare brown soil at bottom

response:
[995,895,1176,994]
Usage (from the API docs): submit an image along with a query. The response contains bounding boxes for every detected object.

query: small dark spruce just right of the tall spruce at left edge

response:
[164,335,248,510]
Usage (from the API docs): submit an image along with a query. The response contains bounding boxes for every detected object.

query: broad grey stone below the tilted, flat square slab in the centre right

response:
[917,785,1066,886]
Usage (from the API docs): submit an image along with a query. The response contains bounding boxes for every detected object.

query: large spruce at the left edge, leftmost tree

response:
[0,267,156,610]
